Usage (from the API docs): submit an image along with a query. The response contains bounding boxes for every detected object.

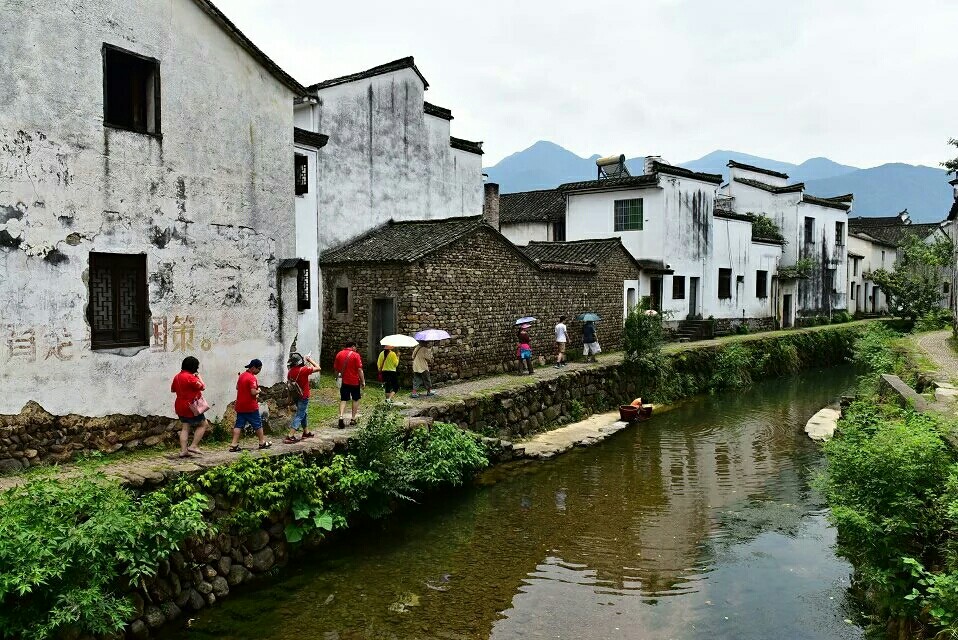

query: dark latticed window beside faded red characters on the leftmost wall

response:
[87,253,149,349]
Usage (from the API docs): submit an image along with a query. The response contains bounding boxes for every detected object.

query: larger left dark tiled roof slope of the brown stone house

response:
[319,216,495,264]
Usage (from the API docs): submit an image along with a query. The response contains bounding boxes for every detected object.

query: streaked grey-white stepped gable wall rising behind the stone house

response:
[315,69,483,252]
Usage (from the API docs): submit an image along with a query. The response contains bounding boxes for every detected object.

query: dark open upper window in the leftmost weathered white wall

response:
[103,44,160,135]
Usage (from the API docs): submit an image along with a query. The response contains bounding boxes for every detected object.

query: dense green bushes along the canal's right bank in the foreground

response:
[817,324,958,638]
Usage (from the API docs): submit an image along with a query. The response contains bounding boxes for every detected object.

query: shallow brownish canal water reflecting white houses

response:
[176,368,863,640]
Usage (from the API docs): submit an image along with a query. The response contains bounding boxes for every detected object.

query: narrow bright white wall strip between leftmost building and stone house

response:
[295,145,323,359]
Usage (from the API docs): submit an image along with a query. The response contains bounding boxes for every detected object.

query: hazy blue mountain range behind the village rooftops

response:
[492,140,953,222]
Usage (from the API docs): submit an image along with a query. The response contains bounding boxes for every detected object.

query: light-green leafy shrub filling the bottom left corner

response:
[0,473,208,640]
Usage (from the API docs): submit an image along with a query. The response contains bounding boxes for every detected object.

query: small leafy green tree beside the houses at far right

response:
[871,236,954,320]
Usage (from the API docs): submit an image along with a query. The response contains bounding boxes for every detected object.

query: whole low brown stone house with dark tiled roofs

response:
[320,216,641,380]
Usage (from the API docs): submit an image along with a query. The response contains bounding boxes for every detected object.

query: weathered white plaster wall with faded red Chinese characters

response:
[0,0,295,415]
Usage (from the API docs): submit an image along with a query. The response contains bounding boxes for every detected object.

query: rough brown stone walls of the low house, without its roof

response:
[323,228,638,380]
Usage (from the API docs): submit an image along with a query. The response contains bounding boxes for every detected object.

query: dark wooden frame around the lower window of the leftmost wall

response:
[87,252,150,351]
